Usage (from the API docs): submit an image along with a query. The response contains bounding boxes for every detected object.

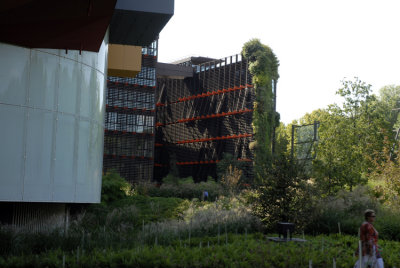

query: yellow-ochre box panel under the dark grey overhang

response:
[107,44,142,77]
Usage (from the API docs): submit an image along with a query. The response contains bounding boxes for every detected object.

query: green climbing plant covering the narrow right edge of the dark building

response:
[242,39,279,183]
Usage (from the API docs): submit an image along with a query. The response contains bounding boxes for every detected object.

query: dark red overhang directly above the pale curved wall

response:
[0,0,116,52]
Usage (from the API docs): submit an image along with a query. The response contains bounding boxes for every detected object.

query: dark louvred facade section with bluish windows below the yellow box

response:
[103,41,157,182]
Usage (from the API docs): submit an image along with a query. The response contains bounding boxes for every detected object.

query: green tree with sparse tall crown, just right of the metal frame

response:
[313,78,387,192]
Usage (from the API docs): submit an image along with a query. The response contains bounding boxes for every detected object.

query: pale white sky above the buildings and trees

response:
[159,0,400,124]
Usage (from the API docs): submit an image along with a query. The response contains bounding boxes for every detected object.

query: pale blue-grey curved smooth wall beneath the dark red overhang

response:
[0,35,108,203]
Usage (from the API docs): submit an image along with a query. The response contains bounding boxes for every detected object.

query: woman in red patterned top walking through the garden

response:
[354,209,384,268]
